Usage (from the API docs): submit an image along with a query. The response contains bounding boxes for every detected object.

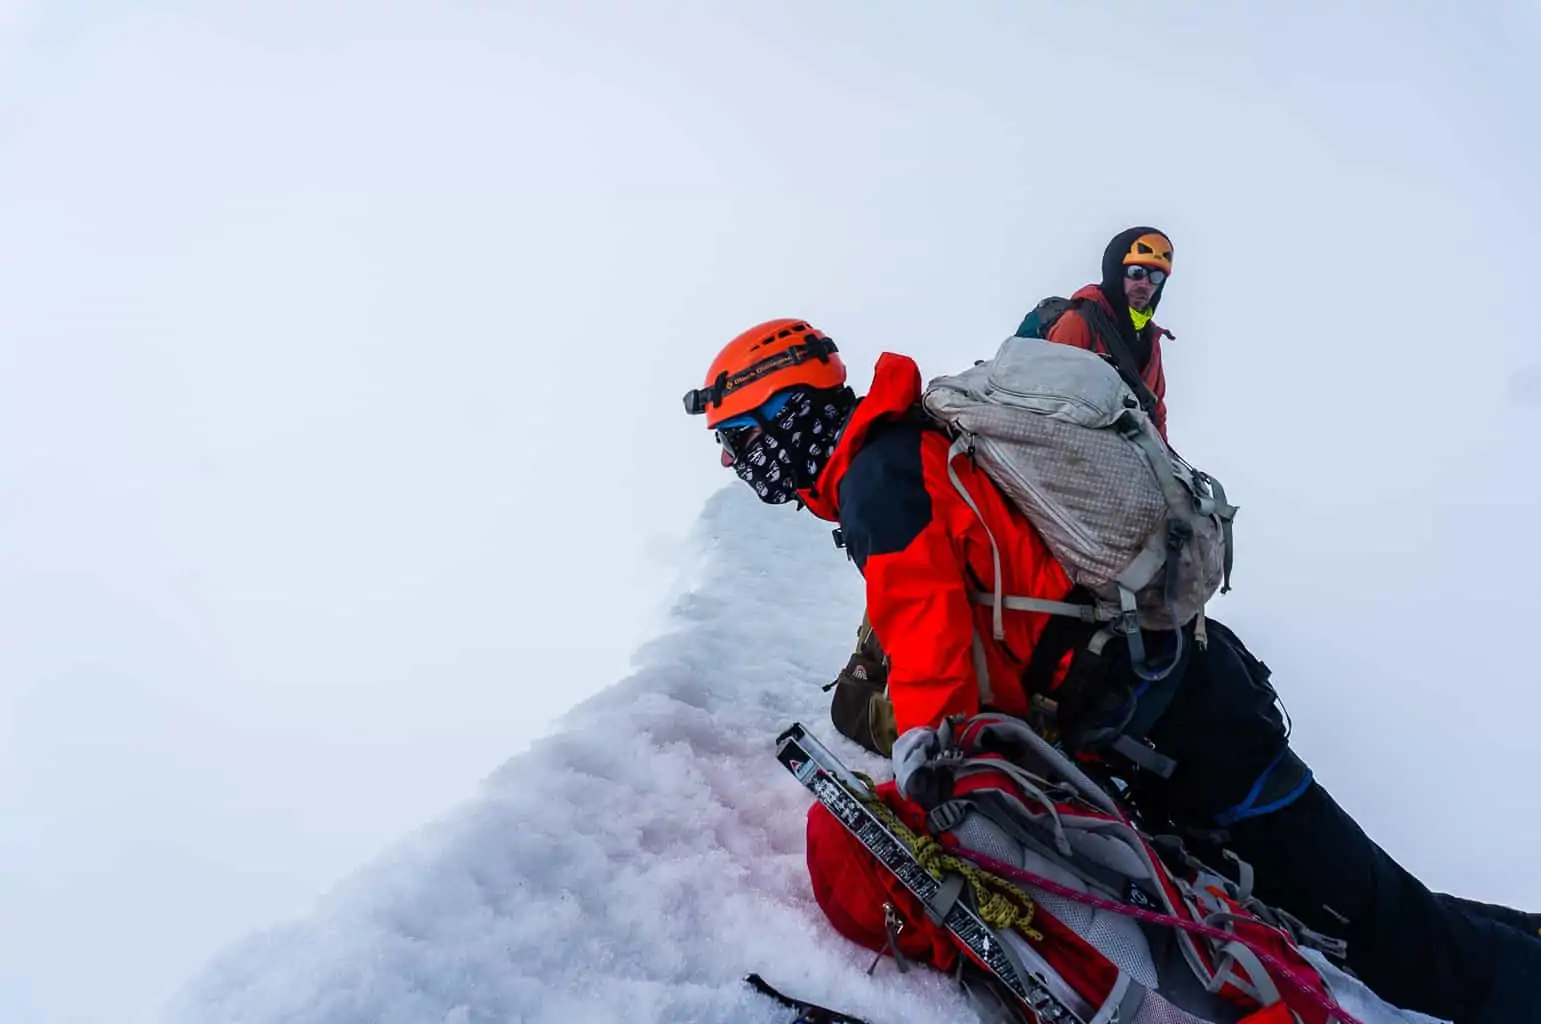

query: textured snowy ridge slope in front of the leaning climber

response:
[171,485,1422,1024]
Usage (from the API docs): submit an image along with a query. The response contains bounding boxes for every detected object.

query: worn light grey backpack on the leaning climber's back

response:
[922,337,1236,679]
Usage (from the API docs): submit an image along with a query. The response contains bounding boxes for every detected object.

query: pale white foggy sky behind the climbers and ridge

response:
[0,0,1541,1021]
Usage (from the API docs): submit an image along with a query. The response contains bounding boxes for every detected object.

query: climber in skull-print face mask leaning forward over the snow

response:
[684,319,1541,1024]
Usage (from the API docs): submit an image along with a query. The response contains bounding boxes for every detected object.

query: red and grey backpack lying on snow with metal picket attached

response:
[778,714,1355,1024]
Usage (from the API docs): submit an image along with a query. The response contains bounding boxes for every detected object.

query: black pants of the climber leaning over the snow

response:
[1131,621,1541,1024]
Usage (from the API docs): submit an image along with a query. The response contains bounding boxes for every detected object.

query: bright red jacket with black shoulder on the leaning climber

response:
[800,353,1071,733]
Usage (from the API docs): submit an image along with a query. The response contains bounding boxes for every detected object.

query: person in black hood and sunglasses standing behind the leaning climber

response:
[1017,226,1173,437]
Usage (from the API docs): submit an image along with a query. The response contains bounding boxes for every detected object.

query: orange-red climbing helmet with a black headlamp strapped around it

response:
[684,317,846,430]
